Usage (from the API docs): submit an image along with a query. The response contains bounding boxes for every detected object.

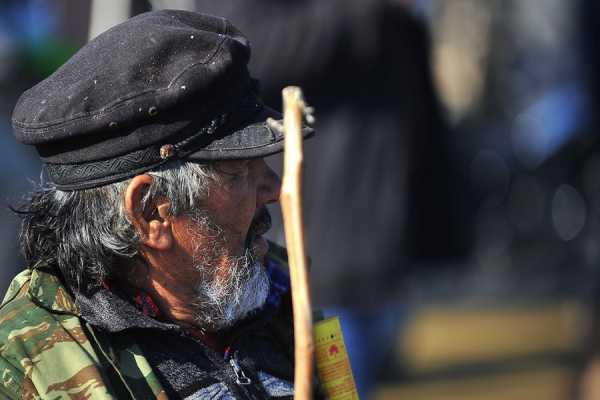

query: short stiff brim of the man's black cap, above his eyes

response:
[185,106,315,161]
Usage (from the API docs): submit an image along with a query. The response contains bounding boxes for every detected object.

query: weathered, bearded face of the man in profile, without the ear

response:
[169,159,280,330]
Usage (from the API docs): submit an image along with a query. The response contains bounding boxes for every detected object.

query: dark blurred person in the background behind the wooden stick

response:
[153,0,463,396]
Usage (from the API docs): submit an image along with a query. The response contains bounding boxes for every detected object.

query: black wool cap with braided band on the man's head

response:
[12,10,313,190]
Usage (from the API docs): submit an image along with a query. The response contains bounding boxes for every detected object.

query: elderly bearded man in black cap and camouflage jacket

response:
[0,11,311,399]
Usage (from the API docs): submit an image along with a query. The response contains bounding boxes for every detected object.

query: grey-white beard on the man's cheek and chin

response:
[192,214,269,331]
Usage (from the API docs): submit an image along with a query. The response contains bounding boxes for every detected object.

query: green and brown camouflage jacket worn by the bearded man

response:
[0,250,300,400]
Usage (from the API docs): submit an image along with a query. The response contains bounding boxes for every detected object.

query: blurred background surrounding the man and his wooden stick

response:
[0,0,600,400]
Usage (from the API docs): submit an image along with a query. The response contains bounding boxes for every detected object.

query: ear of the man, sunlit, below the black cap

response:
[125,174,173,250]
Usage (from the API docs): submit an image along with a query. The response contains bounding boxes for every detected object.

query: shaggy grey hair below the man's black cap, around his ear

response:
[15,161,218,293]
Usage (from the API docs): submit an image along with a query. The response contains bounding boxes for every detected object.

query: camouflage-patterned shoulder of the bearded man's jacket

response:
[0,271,111,398]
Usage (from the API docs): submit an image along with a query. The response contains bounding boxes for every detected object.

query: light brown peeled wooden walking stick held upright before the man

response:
[281,86,314,400]
